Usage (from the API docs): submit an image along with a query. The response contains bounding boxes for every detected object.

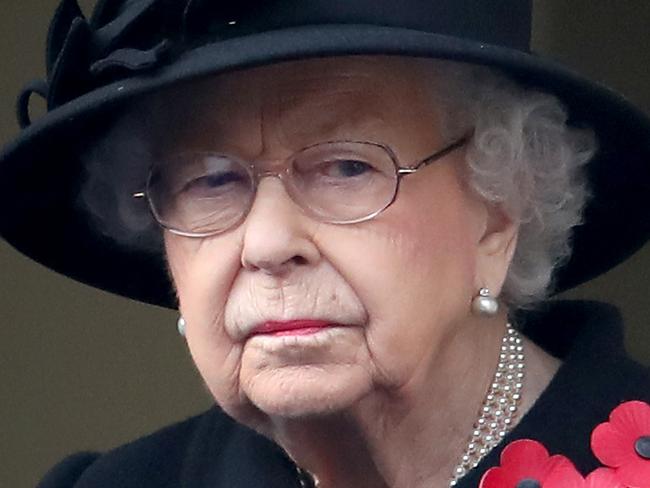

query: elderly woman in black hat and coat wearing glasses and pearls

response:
[0,0,650,488]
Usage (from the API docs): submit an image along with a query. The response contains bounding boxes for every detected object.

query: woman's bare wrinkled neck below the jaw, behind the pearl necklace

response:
[264,317,557,488]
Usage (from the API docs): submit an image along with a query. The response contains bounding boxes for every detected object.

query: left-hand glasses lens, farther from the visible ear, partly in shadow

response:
[148,152,254,235]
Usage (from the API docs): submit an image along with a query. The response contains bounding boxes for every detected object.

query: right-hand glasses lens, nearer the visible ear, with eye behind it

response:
[291,142,397,223]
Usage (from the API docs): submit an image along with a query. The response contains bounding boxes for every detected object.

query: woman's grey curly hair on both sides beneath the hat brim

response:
[80,61,597,308]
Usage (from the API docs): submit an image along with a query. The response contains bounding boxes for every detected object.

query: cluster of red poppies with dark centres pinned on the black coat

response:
[479,401,650,488]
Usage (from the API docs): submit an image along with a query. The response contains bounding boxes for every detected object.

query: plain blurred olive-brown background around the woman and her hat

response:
[0,0,650,488]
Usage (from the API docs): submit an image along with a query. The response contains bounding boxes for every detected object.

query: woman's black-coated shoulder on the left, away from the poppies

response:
[37,408,294,488]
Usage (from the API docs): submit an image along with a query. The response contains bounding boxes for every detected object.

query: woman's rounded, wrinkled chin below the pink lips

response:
[242,365,372,418]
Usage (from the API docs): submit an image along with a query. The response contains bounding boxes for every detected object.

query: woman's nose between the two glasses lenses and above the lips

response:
[241,177,320,275]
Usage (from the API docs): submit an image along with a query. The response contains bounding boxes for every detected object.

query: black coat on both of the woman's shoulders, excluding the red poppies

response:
[38,302,650,488]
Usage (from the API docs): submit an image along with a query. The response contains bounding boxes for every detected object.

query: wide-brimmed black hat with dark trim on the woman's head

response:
[0,0,650,306]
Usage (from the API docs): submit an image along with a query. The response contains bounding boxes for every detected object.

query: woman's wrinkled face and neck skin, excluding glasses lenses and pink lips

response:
[165,57,517,488]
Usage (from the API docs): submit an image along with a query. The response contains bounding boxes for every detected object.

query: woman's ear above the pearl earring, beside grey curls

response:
[475,203,519,296]
